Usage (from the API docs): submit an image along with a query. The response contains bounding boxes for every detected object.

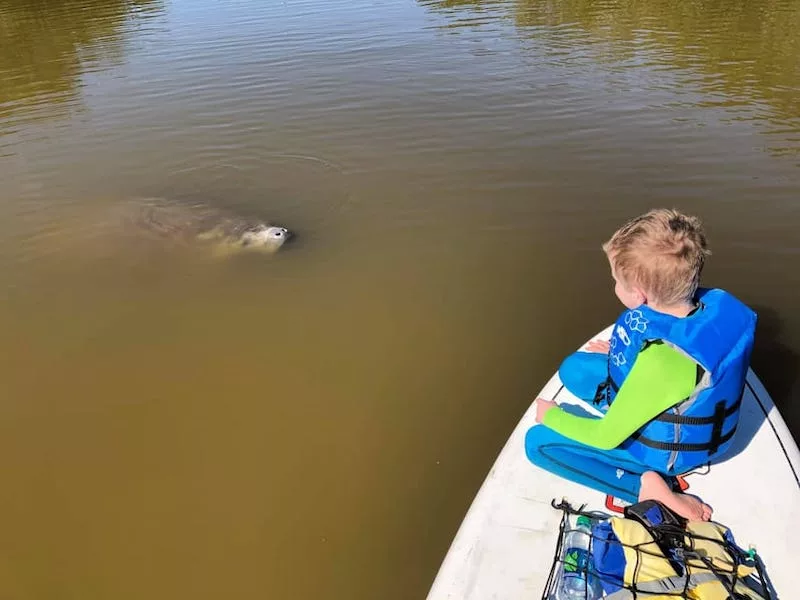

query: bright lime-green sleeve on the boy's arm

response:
[543,344,697,450]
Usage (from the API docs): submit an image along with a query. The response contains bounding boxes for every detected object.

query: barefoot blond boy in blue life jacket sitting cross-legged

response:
[525,209,756,520]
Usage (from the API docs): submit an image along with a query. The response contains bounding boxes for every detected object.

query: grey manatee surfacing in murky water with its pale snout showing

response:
[124,198,292,255]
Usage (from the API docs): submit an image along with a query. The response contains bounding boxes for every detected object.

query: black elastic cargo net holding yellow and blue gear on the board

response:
[542,500,777,600]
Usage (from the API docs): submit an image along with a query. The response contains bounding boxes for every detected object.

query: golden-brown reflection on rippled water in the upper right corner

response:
[419,0,800,155]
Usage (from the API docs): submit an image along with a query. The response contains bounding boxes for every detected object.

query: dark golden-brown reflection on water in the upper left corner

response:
[0,0,163,122]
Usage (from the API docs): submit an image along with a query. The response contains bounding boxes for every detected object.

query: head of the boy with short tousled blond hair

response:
[603,208,710,308]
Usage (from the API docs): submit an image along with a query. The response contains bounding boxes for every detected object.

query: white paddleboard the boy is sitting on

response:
[428,327,800,600]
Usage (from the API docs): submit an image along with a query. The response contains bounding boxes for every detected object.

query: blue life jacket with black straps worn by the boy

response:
[597,289,756,474]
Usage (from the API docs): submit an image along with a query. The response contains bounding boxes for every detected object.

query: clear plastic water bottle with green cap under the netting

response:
[556,516,603,600]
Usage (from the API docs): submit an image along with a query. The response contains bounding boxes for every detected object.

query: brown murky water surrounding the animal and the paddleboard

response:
[0,0,800,600]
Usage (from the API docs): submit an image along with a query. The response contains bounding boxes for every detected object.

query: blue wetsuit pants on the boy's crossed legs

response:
[525,352,673,502]
